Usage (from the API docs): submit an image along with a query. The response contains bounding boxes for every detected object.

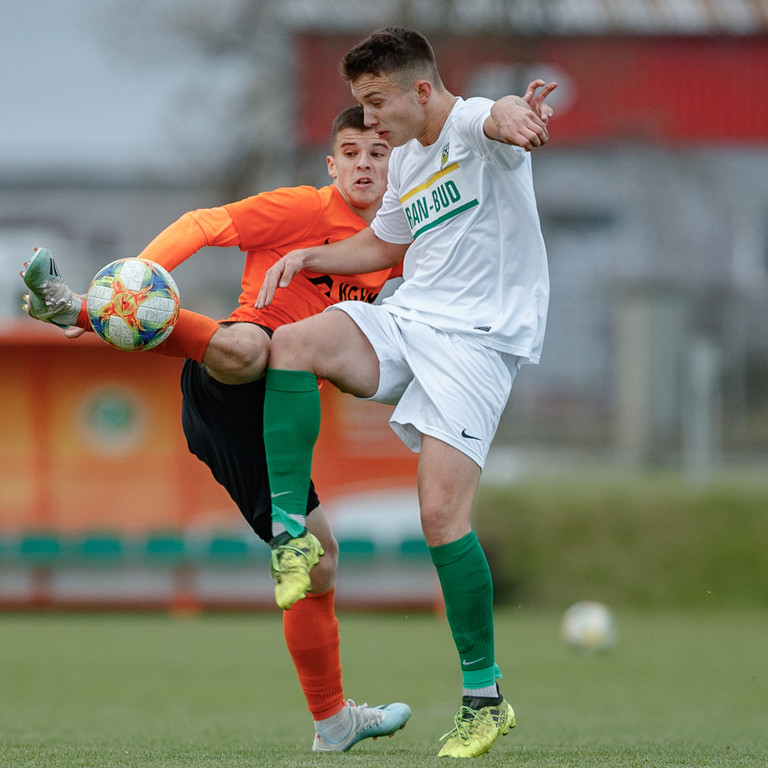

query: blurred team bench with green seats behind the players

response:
[0,531,436,611]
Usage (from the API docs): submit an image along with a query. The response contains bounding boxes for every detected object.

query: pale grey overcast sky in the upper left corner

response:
[0,0,198,172]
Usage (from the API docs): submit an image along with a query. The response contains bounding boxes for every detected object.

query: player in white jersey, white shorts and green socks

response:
[257,28,556,758]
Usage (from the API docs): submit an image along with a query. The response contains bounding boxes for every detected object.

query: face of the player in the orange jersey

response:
[327,128,391,212]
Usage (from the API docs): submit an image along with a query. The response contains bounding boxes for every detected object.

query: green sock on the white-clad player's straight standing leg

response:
[429,531,501,690]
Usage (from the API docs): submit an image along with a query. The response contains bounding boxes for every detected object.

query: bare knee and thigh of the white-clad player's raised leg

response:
[269,311,379,397]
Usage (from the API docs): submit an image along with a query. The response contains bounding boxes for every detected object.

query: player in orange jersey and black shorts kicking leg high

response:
[22,106,410,752]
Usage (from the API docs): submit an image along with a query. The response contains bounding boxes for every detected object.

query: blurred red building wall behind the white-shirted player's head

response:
[300,35,768,147]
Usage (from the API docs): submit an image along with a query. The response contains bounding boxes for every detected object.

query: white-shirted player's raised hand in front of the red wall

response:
[483,80,557,152]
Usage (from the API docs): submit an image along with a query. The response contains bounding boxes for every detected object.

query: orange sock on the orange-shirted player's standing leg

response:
[283,589,346,721]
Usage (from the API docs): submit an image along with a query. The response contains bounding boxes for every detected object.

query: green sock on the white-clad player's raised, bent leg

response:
[264,368,320,538]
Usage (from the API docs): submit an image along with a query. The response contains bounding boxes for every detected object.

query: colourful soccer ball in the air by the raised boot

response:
[87,259,179,351]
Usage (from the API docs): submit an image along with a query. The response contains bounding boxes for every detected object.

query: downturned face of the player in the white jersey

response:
[352,75,425,147]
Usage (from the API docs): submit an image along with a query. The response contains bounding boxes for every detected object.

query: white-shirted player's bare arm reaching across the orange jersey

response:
[255,227,408,309]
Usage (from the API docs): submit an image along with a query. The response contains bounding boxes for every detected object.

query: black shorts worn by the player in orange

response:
[181,360,320,542]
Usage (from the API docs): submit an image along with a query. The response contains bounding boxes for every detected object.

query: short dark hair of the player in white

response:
[340,27,440,84]
